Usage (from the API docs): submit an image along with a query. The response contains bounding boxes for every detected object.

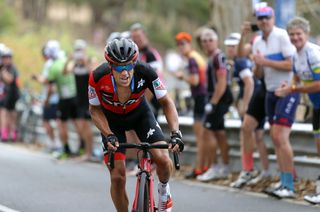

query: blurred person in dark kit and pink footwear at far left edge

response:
[0,47,20,141]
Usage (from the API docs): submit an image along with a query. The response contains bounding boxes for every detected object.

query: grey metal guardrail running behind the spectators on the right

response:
[158,116,320,179]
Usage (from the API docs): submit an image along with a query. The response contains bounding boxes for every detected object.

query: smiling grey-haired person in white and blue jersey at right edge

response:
[276,17,320,204]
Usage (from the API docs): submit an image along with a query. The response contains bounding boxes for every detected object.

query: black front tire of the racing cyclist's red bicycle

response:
[137,172,151,212]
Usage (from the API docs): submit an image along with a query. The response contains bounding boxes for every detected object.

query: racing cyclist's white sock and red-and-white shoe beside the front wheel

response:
[158,183,173,212]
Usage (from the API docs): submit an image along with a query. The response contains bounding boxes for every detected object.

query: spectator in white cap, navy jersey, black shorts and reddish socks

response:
[225,28,270,188]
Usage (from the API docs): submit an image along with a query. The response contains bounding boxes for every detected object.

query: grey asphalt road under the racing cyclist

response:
[0,143,320,212]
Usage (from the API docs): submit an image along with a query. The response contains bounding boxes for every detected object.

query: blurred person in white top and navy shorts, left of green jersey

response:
[32,46,61,152]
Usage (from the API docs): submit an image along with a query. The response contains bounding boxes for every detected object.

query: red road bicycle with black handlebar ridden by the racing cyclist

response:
[108,142,180,212]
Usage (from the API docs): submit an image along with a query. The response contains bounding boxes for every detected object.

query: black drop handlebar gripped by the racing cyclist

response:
[107,142,180,170]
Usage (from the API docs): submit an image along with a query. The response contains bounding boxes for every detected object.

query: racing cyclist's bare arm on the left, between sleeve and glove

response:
[89,104,112,136]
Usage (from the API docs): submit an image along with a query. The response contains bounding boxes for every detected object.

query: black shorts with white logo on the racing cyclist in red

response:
[101,99,165,153]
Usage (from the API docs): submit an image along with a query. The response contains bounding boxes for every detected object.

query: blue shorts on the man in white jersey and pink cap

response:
[265,91,300,127]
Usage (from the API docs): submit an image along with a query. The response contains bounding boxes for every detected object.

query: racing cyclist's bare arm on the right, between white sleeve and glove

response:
[158,95,179,131]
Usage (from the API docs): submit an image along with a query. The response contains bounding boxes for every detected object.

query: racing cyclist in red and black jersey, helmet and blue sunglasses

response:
[88,38,183,212]
